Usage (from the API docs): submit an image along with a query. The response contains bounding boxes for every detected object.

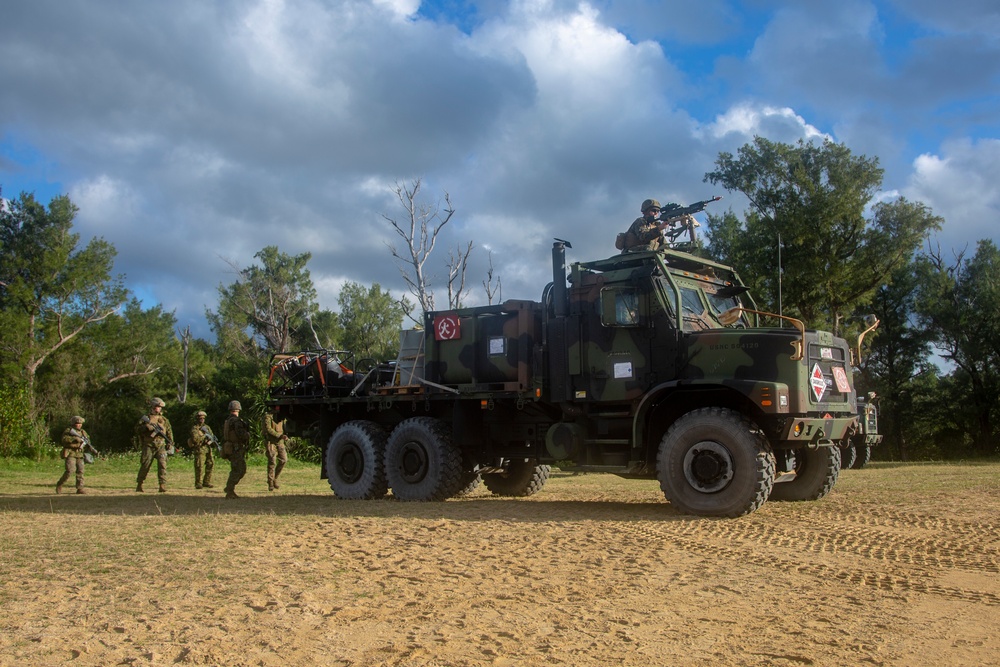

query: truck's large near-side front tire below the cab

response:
[656,408,774,517]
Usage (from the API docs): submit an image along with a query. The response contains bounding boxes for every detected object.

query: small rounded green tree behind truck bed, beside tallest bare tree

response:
[338,282,411,360]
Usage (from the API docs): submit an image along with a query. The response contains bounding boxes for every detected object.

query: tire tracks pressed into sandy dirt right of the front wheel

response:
[624,508,1000,606]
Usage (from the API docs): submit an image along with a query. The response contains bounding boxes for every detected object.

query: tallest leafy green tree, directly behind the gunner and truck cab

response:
[705,137,941,334]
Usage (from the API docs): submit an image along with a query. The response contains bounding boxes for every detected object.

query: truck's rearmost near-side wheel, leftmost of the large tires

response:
[326,421,389,500]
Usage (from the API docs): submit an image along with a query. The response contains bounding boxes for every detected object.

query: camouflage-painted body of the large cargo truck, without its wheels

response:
[271,243,857,488]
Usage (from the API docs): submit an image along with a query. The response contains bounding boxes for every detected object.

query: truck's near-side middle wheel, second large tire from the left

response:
[385,417,464,500]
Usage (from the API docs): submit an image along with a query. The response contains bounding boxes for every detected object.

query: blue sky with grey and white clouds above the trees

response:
[0,0,1000,337]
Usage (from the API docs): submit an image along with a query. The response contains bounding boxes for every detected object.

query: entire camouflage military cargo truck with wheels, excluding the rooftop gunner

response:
[269,240,859,517]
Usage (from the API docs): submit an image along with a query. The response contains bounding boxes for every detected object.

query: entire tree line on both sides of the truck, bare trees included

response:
[0,143,1000,460]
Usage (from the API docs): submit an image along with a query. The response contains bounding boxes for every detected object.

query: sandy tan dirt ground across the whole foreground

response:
[0,466,1000,667]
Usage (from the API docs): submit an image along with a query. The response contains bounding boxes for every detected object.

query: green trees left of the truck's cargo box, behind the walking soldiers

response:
[0,182,426,459]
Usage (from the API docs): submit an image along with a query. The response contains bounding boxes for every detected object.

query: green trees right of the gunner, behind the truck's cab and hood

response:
[705,137,1000,460]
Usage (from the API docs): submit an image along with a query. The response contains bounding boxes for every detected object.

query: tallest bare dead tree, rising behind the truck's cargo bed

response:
[382,178,458,312]
